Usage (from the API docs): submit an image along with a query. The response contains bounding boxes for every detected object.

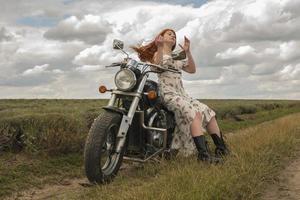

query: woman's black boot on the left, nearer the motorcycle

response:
[193,135,222,164]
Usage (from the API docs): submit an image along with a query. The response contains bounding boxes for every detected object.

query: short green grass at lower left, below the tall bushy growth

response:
[0,153,83,198]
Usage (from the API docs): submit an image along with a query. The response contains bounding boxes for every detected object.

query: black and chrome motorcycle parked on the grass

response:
[84,40,186,183]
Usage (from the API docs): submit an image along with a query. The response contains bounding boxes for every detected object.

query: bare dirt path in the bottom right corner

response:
[262,151,300,200]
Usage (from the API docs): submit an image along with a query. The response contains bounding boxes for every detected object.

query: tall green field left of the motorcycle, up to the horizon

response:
[0,100,107,154]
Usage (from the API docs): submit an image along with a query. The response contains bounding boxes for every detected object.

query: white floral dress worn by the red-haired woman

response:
[158,55,216,156]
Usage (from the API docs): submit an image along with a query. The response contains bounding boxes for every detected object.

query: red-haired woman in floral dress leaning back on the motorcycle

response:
[132,29,229,163]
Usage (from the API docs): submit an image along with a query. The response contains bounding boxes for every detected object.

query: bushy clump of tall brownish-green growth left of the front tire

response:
[0,114,88,154]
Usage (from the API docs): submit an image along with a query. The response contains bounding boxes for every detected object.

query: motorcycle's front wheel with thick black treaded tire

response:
[84,110,125,184]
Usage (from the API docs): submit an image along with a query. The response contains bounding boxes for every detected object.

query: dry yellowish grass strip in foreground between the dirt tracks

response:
[64,114,300,200]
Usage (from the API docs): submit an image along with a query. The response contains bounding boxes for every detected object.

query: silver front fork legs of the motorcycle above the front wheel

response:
[108,74,148,153]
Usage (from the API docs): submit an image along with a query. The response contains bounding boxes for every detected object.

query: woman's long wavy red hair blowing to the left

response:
[131,28,176,63]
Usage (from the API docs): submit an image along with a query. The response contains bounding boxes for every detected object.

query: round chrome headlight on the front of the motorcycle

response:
[115,69,136,91]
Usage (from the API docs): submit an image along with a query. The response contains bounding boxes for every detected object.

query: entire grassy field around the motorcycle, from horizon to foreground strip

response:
[0,100,300,199]
